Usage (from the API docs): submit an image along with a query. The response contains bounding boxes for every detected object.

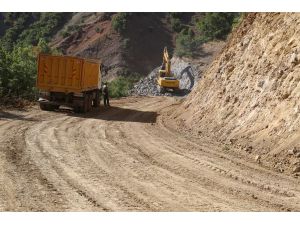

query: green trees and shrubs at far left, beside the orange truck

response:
[0,13,70,99]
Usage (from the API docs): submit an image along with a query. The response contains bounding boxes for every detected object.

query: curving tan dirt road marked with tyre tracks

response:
[0,97,300,211]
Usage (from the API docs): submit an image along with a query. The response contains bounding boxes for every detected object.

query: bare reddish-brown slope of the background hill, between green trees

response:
[51,13,175,76]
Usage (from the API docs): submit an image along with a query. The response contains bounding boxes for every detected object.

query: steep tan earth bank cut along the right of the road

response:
[172,13,300,172]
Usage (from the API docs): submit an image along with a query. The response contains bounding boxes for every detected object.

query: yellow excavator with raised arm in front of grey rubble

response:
[157,47,179,93]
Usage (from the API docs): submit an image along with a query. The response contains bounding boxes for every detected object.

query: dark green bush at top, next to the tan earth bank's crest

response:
[198,13,240,40]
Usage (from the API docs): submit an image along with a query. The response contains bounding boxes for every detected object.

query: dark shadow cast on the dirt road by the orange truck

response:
[63,106,157,123]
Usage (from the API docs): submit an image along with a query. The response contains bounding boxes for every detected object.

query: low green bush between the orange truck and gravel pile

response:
[108,75,139,98]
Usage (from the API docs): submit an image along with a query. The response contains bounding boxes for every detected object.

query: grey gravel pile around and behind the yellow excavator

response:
[130,57,199,96]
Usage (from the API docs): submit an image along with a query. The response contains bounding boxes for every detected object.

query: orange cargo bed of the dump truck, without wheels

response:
[37,54,101,93]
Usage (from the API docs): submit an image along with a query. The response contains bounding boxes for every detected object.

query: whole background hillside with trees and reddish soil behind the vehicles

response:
[0,12,242,102]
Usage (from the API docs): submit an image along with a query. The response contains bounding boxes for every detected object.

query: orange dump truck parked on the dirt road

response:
[36,54,103,113]
